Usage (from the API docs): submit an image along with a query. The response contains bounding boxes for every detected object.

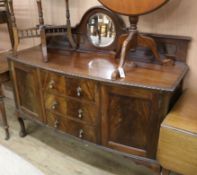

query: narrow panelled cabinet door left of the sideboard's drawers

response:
[10,61,43,122]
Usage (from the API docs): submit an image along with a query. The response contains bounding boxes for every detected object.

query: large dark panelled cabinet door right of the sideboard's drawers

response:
[102,86,162,158]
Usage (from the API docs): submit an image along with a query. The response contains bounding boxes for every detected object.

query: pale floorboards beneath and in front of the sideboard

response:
[0,99,153,175]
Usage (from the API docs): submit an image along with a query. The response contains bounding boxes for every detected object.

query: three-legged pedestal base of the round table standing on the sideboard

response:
[112,16,174,80]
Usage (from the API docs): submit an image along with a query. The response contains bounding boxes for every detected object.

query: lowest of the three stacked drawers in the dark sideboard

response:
[47,112,99,143]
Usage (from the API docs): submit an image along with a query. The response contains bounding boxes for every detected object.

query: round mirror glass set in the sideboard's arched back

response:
[87,13,116,47]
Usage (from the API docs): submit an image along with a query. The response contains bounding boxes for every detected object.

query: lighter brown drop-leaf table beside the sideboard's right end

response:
[157,91,197,175]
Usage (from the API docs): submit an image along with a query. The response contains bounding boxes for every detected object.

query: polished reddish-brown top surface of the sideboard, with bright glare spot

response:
[8,47,188,92]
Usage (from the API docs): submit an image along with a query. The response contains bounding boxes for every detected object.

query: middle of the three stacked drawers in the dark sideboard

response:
[45,93,99,125]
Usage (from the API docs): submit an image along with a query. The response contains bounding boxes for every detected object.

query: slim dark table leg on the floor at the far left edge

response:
[0,85,10,140]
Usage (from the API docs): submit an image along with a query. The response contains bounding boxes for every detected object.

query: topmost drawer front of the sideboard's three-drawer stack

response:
[41,71,98,102]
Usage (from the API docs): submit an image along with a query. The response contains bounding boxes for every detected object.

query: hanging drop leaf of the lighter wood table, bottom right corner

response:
[157,127,197,175]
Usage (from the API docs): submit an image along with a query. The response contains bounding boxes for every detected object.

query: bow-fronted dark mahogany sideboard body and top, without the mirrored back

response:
[8,44,188,172]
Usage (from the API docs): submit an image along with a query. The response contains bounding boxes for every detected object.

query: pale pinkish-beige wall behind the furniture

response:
[0,0,197,88]
